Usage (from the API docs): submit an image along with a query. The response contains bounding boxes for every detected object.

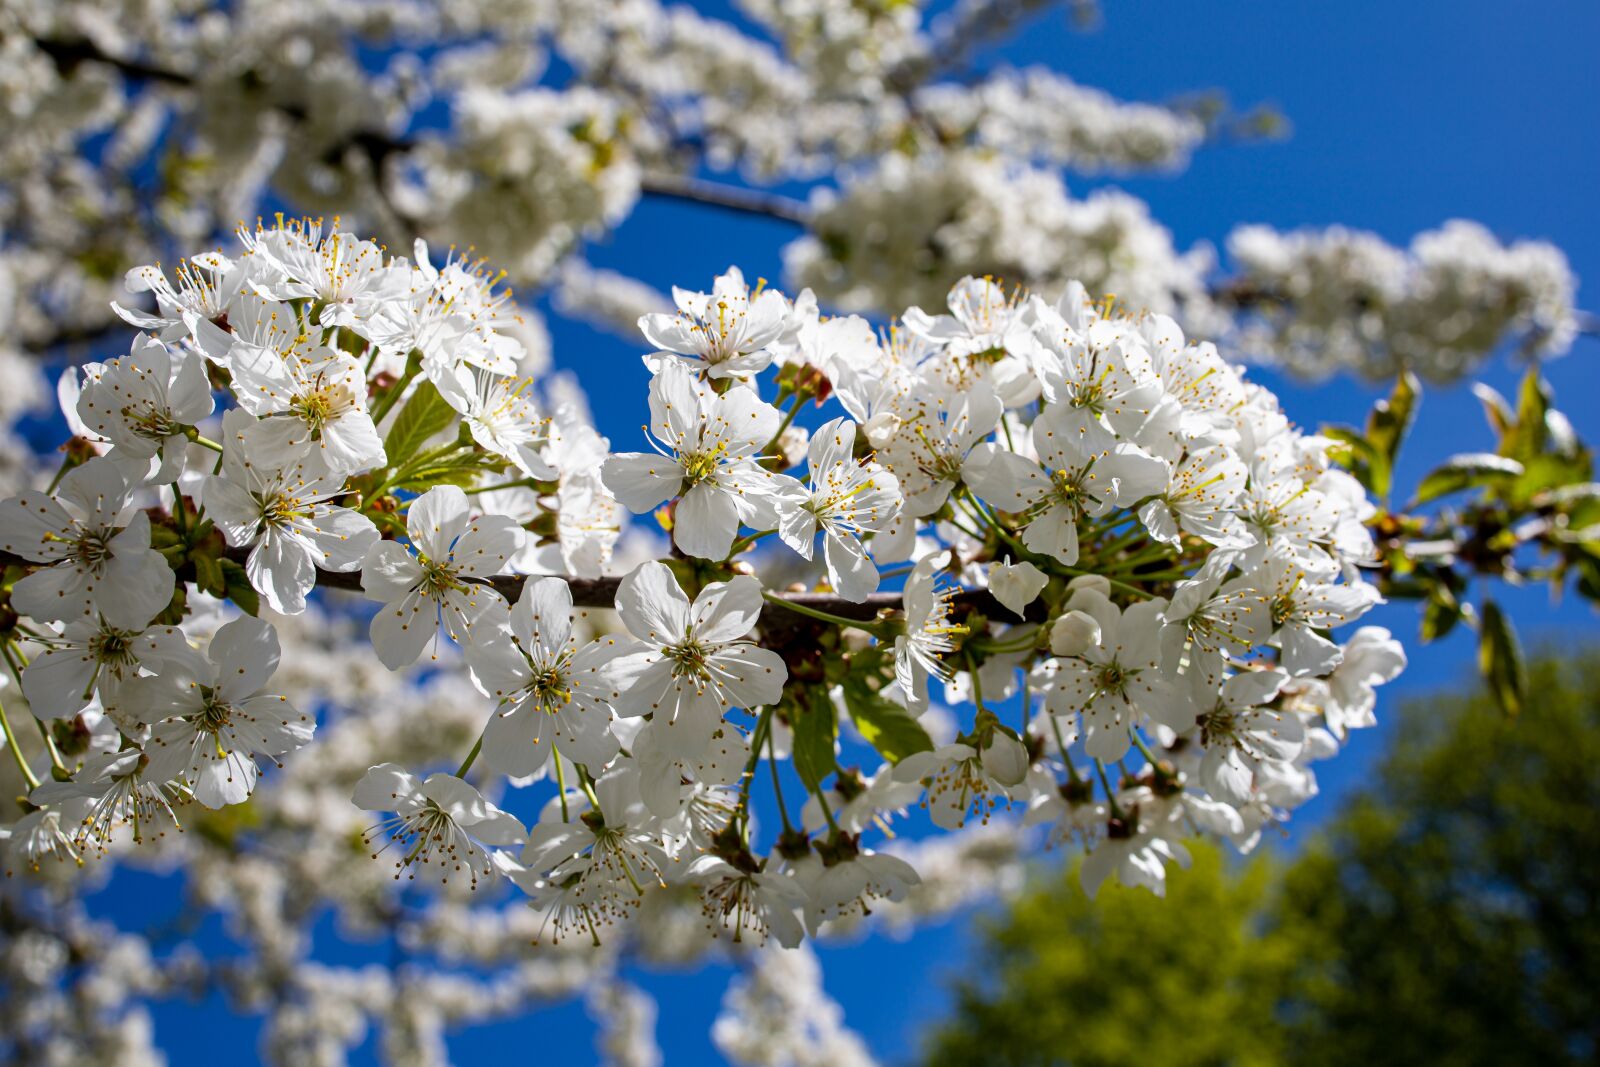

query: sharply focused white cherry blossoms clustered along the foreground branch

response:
[0,219,1405,947]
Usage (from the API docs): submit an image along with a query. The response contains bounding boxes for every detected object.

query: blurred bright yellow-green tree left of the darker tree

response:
[928,846,1280,1067]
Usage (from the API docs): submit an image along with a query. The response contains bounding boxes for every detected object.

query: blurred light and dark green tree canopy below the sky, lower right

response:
[925,654,1600,1067]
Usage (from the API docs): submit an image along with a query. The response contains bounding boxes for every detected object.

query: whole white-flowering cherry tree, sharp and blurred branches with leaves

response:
[0,0,1600,1064]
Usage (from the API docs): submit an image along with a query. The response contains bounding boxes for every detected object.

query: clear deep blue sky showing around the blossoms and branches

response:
[72,0,1600,1064]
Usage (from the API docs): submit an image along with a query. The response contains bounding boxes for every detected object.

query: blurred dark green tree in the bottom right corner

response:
[1275,659,1600,1064]
